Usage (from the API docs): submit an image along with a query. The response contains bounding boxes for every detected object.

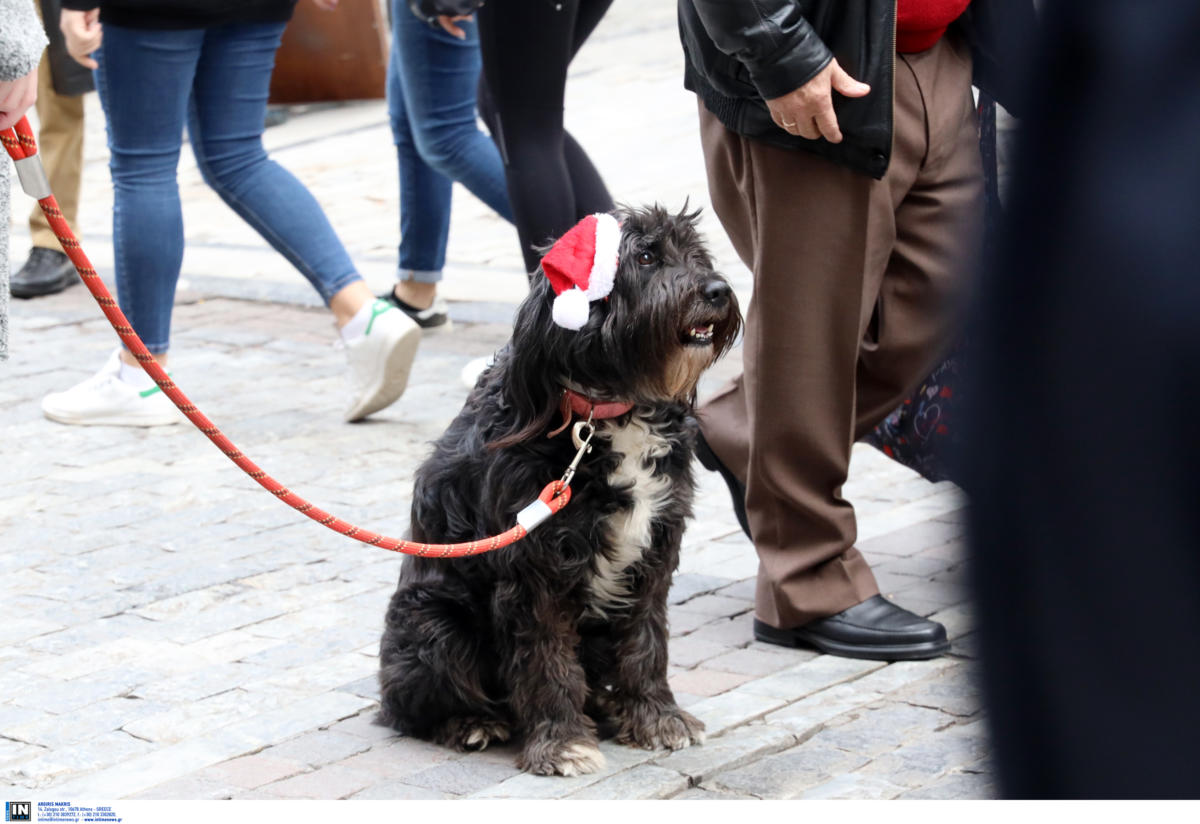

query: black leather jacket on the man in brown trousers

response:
[678,0,1034,178]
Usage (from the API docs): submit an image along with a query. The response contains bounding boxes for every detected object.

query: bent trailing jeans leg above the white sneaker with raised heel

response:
[187,23,361,303]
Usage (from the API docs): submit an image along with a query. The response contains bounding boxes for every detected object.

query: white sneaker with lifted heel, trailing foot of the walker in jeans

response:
[346,300,421,421]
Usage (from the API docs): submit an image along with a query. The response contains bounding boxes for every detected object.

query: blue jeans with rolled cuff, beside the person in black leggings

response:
[388,0,512,283]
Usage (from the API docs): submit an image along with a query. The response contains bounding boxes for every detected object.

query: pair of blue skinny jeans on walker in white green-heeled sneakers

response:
[96,23,361,354]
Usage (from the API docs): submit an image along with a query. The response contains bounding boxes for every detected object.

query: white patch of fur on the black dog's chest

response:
[590,417,671,614]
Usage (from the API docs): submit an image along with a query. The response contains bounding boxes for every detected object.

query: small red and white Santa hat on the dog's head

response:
[541,213,620,330]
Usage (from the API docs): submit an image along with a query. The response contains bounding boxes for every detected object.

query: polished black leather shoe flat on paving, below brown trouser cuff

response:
[754,595,950,661]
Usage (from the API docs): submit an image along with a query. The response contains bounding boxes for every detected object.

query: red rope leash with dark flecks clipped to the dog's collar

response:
[0,118,571,558]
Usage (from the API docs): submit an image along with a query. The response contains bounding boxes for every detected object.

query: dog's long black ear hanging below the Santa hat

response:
[488,269,570,449]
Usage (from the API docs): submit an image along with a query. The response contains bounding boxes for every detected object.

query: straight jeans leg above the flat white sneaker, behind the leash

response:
[96,24,204,354]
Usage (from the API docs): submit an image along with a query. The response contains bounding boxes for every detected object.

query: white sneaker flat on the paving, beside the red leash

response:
[42,351,186,426]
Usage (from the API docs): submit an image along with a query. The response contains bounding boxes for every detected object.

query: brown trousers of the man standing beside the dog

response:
[700,37,983,628]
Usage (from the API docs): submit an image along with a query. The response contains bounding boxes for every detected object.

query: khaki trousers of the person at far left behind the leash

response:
[29,4,83,252]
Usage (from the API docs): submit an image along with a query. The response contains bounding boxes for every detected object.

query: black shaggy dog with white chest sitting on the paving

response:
[378,206,742,775]
